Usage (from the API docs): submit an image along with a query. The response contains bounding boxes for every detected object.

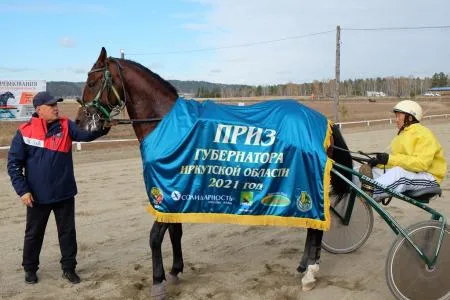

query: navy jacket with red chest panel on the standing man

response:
[8,116,107,204]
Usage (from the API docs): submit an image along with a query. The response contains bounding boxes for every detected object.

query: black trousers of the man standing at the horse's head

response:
[22,198,77,271]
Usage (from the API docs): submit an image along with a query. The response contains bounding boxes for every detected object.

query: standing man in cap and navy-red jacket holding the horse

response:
[8,92,108,284]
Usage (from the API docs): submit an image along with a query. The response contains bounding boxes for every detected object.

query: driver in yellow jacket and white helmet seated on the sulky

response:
[360,100,447,201]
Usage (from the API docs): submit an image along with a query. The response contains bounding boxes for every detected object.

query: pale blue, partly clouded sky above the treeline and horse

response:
[0,0,450,85]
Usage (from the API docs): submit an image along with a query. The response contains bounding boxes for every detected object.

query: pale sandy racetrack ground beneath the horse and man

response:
[0,123,450,300]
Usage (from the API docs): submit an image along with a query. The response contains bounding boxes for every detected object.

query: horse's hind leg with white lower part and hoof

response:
[297,228,323,291]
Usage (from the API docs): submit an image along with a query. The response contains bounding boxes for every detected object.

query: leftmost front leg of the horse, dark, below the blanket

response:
[150,221,169,300]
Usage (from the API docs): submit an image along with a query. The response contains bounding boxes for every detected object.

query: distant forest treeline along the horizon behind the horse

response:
[47,72,450,98]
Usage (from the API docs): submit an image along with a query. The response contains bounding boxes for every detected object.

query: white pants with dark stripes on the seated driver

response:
[353,165,439,200]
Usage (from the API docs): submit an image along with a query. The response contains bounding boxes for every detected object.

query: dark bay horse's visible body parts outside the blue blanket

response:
[75,48,352,299]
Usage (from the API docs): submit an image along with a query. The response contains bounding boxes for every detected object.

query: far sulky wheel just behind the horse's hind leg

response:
[322,193,373,254]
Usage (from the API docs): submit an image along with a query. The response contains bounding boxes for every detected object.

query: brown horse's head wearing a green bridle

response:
[76,48,126,131]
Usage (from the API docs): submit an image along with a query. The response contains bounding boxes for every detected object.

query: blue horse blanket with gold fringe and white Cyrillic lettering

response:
[141,98,332,230]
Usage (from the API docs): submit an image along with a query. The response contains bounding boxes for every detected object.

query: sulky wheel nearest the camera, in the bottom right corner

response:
[386,220,450,300]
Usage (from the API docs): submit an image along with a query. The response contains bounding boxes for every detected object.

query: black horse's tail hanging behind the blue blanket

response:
[331,124,353,198]
